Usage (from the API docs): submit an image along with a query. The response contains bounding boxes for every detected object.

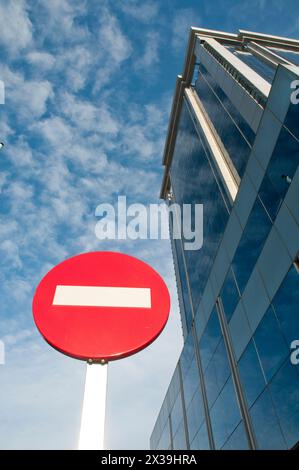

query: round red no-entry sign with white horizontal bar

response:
[33,251,170,361]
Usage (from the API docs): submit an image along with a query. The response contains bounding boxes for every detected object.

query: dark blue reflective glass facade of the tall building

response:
[151,30,299,450]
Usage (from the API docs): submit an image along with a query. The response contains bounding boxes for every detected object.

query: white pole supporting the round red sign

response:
[78,363,108,450]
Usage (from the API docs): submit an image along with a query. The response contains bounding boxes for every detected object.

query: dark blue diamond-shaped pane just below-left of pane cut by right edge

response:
[254,306,289,382]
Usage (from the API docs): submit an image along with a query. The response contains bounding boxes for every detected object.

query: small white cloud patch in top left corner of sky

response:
[0,0,32,54]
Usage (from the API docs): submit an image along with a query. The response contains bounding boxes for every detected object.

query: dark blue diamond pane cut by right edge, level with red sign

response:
[272,266,299,344]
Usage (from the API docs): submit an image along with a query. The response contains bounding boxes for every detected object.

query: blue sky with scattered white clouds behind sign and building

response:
[0,0,299,449]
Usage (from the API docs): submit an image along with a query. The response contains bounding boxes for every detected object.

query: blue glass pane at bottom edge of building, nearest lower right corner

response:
[250,388,286,450]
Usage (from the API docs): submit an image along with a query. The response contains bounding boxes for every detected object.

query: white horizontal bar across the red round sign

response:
[53,285,151,308]
